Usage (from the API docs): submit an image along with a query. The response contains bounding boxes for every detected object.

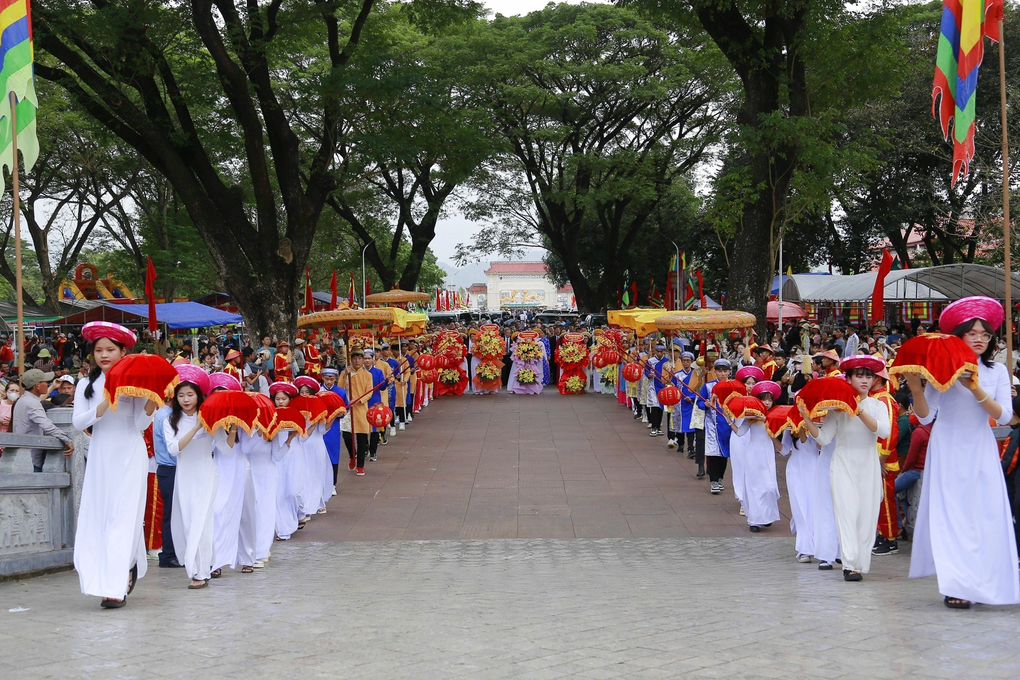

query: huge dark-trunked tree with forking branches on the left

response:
[34,0,473,336]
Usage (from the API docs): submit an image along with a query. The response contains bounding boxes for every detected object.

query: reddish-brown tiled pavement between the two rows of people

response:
[296,389,791,541]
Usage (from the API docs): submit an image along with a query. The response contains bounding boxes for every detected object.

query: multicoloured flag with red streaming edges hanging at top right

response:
[931,0,1003,186]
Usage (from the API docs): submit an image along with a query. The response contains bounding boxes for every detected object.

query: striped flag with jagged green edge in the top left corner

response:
[0,0,39,184]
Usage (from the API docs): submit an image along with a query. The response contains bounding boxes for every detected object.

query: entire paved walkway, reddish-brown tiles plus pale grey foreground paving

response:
[0,396,1020,680]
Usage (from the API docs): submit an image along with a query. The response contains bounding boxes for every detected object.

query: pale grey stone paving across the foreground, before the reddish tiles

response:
[0,538,1020,680]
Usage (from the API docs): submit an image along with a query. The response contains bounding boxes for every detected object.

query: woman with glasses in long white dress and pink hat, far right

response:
[907,297,1020,609]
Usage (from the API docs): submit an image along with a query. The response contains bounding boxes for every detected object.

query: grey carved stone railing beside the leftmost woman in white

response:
[0,408,89,579]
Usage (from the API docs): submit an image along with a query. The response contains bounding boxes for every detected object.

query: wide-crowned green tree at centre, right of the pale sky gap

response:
[461,4,729,311]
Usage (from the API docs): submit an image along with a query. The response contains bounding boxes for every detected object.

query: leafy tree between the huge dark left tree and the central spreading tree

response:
[329,7,493,290]
